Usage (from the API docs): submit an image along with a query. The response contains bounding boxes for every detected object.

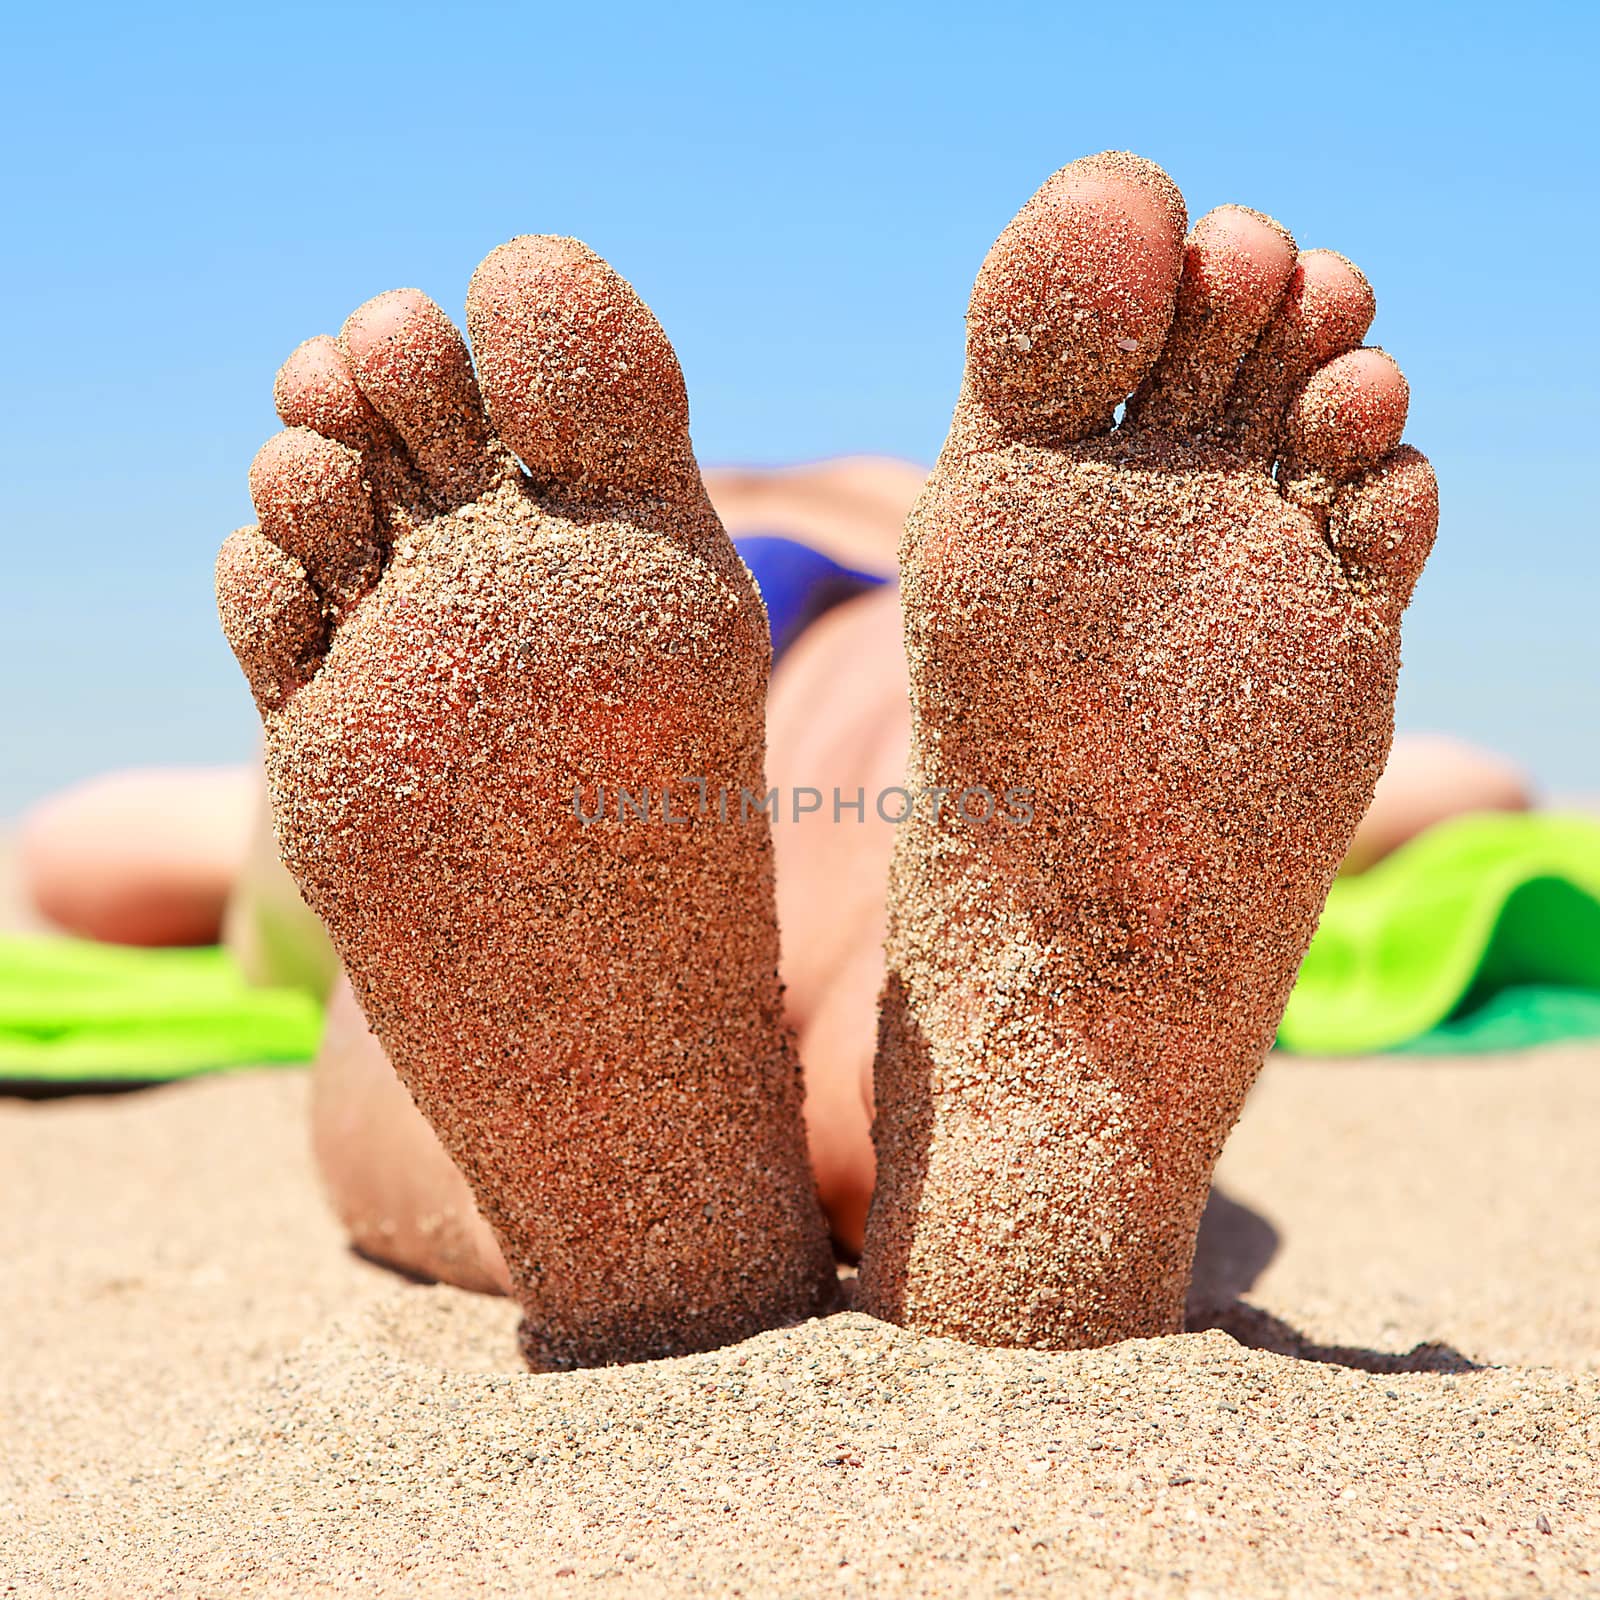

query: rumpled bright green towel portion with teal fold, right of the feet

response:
[1278,813,1600,1056]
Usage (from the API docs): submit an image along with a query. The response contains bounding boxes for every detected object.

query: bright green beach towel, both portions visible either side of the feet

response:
[0,814,1600,1086]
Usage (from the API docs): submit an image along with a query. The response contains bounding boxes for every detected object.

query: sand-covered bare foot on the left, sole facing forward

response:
[218,238,832,1365]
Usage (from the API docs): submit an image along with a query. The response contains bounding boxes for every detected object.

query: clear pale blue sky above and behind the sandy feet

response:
[0,0,1600,818]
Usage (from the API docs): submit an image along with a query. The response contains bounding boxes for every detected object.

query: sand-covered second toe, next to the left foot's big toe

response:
[339,290,498,506]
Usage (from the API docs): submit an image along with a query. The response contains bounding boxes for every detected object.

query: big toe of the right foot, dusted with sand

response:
[955,152,1184,448]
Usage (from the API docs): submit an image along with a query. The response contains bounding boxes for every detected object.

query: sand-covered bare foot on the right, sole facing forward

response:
[861,155,1437,1349]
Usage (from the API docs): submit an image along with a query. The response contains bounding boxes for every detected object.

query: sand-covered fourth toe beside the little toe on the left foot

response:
[250,427,381,613]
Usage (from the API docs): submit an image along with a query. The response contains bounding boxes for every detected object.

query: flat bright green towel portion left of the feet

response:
[0,936,322,1083]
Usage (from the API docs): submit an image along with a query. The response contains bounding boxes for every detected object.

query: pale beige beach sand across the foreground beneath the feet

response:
[0,1048,1600,1597]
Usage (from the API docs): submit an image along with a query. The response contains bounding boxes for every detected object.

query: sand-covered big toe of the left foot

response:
[467,234,699,499]
